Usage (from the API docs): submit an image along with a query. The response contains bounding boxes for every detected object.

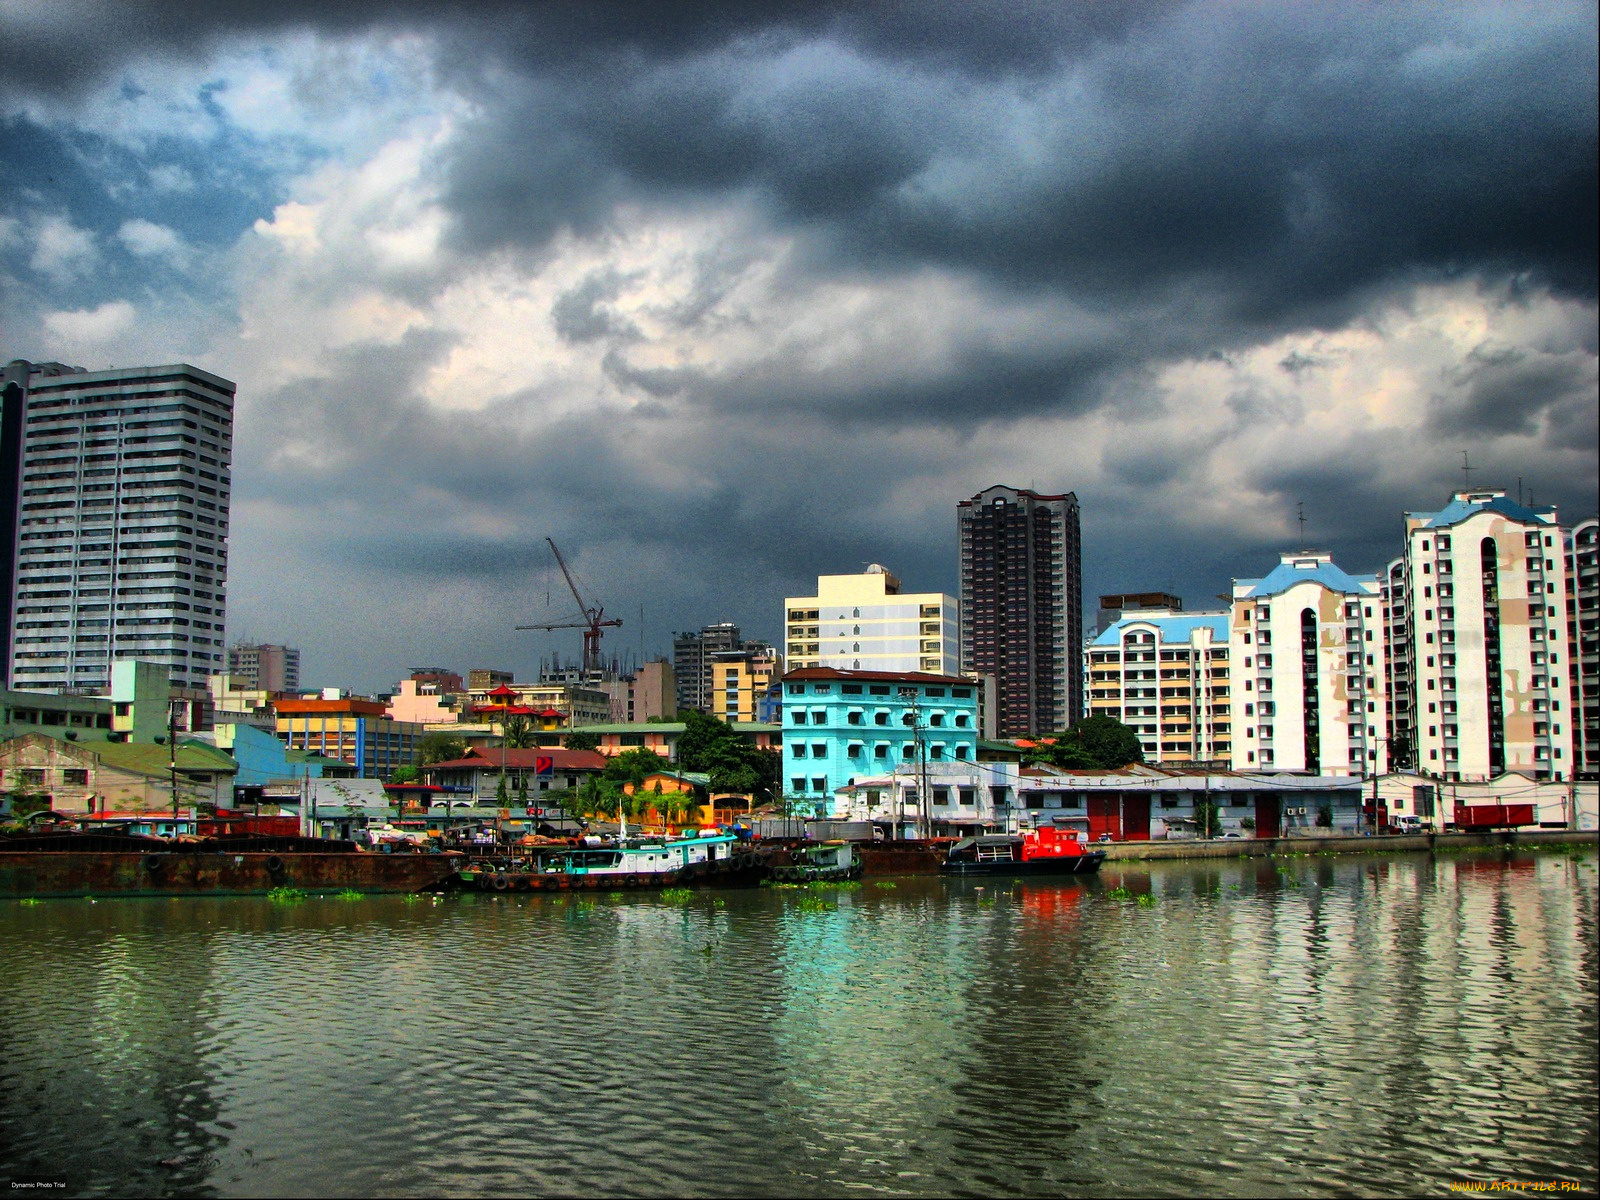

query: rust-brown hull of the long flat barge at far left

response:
[0,850,461,898]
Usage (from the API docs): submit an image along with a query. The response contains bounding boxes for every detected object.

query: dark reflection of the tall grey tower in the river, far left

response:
[0,901,227,1195]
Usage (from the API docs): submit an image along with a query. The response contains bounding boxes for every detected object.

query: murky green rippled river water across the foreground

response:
[0,851,1600,1197]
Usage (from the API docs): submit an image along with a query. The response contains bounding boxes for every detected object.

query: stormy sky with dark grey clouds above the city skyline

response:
[0,0,1600,690]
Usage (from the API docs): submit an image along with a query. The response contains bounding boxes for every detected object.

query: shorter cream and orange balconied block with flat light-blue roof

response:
[1088,614,1234,765]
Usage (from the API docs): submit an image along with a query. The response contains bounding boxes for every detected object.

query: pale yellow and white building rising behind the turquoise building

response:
[784,563,962,675]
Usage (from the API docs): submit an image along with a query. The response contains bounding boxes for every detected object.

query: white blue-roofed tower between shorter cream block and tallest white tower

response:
[1229,550,1389,776]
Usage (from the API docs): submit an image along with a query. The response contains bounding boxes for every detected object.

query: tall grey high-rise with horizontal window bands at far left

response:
[0,360,235,691]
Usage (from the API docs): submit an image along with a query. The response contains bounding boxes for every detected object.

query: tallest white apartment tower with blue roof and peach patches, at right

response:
[1389,488,1579,782]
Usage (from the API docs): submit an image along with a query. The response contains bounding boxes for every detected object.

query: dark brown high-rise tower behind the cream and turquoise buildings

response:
[955,486,1083,738]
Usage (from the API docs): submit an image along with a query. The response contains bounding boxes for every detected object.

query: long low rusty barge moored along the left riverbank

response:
[0,832,462,899]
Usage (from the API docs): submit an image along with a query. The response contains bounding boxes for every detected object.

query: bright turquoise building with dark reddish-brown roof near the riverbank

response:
[782,667,978,811]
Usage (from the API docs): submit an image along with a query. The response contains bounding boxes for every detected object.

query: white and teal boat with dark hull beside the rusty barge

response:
[458,829,770,891]
